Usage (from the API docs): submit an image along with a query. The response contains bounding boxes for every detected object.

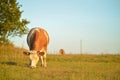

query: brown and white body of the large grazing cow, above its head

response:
[27,28,49,51]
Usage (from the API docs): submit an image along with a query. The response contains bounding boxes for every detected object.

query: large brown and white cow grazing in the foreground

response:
[23,28,49,68]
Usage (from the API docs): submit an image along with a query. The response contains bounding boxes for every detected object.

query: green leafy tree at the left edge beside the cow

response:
[0,0,29,44]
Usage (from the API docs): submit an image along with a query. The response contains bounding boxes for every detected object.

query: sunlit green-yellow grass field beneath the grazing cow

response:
[0,46,120,80]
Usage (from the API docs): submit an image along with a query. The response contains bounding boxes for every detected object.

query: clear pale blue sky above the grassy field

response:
[11,0,120,54]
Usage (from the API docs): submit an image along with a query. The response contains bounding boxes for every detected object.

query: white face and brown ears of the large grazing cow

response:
[23,50,44,68]
